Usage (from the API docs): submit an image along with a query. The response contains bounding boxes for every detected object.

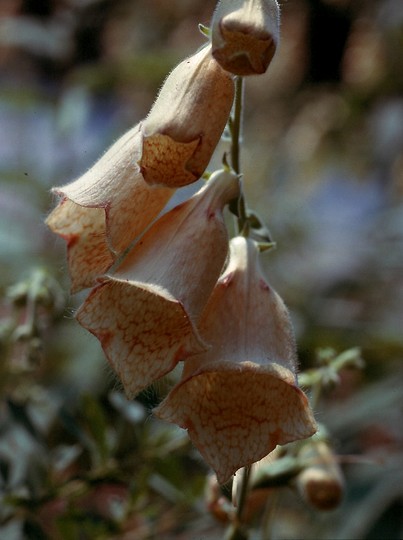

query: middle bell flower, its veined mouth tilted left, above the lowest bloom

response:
[77,171,239,397]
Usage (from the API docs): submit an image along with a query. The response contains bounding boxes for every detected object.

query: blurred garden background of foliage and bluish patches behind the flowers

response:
[0,0,403,540]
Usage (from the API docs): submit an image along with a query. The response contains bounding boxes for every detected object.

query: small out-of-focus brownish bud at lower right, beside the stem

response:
[296,440,344,511]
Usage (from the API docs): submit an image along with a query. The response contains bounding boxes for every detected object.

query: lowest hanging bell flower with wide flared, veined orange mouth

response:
[155,237,316,483]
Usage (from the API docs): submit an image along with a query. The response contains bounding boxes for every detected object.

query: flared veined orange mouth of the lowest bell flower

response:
[154,362,316,483]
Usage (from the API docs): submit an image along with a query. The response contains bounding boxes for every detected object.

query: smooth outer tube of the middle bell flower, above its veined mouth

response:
[114,171,239,321]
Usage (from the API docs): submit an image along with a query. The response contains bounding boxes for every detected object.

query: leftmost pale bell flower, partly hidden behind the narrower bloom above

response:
[46,125,173,292]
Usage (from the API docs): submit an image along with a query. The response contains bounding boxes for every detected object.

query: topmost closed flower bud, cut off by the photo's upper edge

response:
[211,0,280,76]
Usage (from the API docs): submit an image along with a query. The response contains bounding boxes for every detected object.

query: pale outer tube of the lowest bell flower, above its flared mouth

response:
[184,236,296,382]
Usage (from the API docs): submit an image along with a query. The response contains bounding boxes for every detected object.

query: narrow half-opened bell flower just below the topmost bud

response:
[139,46,234,187]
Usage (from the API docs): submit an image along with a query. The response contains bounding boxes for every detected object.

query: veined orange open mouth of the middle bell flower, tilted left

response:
[77,278,205,398]
